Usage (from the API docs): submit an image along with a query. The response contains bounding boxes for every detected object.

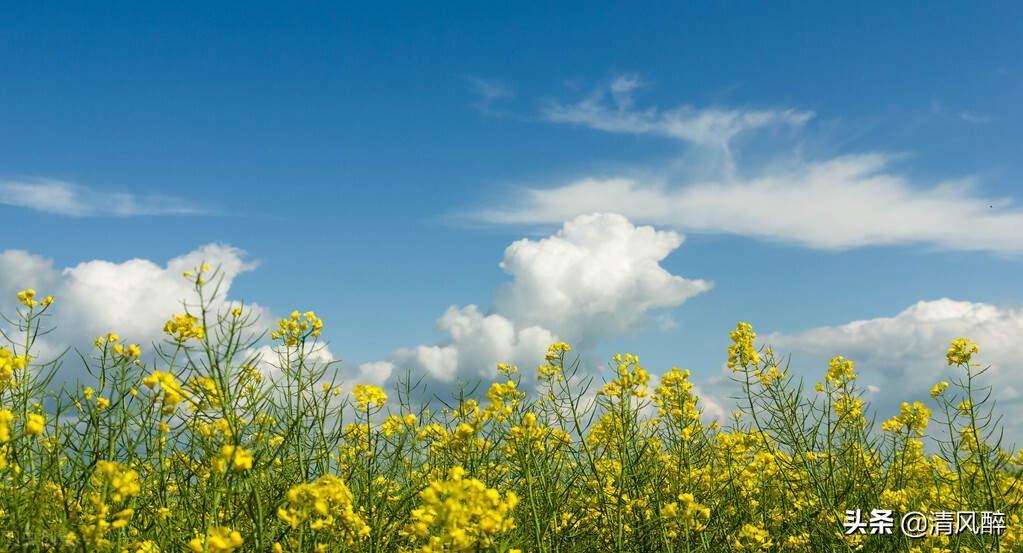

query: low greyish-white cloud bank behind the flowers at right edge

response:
[763,298,1023,446]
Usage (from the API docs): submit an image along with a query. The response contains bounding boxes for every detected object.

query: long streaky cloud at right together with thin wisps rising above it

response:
[466,78,1023,255]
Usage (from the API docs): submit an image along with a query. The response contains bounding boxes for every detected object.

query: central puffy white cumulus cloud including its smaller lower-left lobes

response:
[380,214,711,382]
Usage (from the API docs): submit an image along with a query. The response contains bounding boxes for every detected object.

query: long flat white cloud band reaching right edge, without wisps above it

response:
[479,153,1023,255]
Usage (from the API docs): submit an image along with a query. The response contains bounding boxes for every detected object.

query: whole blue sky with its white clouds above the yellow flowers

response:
[0,2,1023,442]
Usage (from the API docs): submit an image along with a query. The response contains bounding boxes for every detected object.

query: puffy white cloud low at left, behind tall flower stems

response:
[0,244,269,380]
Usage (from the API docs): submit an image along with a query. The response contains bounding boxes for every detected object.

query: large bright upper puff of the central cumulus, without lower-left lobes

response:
[494,214,711,344]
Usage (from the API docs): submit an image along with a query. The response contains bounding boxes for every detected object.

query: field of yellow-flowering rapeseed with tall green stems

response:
[0,266,1023,553]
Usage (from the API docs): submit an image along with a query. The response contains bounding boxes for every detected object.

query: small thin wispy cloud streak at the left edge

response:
[0,179,205,217]
